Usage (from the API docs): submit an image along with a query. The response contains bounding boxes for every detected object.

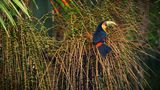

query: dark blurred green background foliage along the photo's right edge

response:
[145,0,160,90]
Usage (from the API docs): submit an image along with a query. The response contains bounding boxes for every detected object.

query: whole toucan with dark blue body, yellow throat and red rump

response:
[93,21,117,58]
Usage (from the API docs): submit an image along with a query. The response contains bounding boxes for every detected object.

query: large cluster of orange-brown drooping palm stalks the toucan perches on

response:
[46,0,150,90]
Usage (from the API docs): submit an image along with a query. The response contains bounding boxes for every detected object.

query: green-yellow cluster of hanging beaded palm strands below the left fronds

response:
[0,19,51,90]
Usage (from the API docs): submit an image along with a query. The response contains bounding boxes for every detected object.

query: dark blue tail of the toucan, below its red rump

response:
[98,43,112,58]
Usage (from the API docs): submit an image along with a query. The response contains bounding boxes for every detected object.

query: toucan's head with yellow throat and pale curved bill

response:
[102,21,117,32]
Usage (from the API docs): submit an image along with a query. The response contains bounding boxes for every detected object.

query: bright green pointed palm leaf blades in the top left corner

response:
[0,0,30,33]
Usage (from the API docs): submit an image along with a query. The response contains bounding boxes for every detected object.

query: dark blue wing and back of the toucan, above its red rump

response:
[93,31,107,44]
